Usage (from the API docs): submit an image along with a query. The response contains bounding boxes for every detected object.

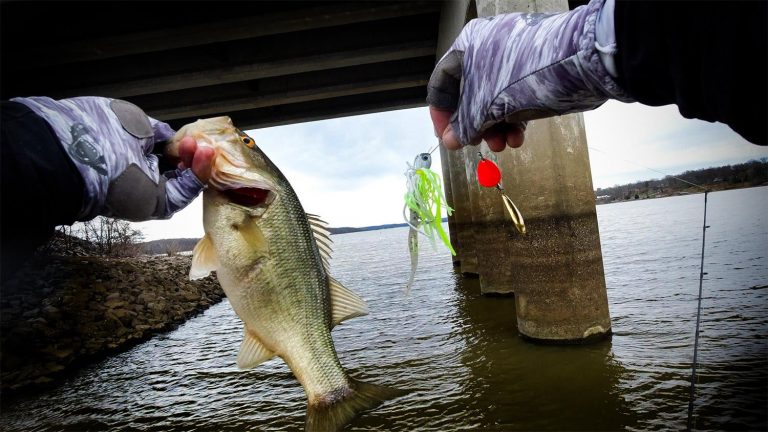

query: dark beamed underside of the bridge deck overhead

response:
[0,1,441,129]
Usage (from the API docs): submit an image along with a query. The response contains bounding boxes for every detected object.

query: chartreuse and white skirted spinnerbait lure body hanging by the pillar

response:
[403,153,456,295]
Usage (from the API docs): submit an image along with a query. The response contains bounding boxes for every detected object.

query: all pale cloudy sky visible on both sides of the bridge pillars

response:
[133,101,768,241]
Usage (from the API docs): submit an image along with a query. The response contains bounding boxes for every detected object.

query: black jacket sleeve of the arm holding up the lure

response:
[615,0,768,145]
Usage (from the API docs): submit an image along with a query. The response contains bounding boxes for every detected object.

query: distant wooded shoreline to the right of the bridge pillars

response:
[595,157,768,203]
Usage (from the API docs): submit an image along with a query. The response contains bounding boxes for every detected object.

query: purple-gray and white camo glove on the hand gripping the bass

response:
[13,97,204,221]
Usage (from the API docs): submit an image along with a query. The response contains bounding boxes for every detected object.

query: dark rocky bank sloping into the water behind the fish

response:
[0,251,224,395]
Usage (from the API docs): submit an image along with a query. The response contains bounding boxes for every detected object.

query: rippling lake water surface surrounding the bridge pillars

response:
[0,188,768,431]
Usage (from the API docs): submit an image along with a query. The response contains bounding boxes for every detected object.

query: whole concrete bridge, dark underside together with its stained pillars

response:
[0,0,610,342]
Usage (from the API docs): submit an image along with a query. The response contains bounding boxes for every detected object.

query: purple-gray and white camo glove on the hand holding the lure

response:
[427,0,632,145]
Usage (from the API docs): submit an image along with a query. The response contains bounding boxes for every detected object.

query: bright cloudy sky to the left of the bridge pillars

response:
[135,107,442,240]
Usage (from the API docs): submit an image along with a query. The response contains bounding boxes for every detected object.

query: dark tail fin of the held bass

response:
[304,378,408,432]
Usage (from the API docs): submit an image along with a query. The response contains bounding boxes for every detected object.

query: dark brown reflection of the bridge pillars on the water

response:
[450,280,633,430]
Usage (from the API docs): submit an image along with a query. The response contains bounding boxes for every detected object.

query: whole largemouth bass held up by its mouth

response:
[167,117,406,431]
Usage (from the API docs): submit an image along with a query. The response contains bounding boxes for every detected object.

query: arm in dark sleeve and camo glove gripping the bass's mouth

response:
[0,96,218,278]
